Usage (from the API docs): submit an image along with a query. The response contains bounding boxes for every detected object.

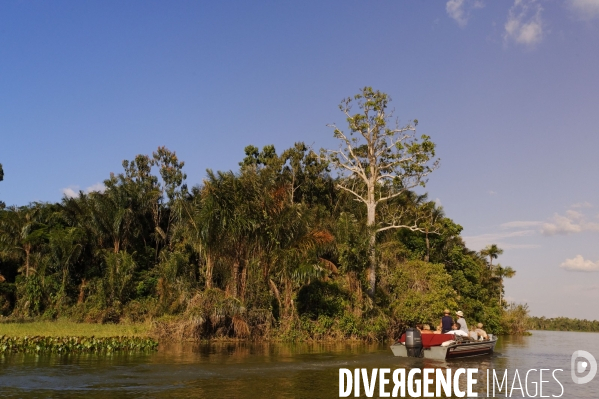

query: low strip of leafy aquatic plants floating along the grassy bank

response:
[0,335,158,353]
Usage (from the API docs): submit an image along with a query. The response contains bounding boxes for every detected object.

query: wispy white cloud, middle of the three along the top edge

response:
[503,0,544,46]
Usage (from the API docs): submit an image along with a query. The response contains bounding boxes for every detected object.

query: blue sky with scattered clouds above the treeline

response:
[0,0,599,319]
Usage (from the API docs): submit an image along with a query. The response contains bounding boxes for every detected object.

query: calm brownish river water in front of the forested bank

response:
[0,331,599,399]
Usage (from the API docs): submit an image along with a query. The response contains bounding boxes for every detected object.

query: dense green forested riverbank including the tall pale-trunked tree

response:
[0,87,527,340]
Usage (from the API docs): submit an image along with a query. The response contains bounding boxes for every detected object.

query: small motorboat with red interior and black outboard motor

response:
[391,328,497,360]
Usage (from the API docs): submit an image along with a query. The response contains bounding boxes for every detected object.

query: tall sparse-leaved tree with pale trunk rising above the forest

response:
[328,87,439,297]
